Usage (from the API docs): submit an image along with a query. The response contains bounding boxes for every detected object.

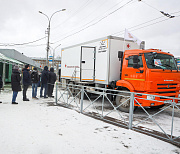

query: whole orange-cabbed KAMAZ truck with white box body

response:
[61,36,180,112]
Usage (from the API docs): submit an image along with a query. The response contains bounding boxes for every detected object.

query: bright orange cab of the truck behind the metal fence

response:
[116,49,180,110]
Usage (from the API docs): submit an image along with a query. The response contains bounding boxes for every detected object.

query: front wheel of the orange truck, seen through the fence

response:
[116,93,137,113]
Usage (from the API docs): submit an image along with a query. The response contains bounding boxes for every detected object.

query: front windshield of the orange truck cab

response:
[144,53,177,70]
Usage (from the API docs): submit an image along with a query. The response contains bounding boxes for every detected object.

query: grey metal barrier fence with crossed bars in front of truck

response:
[55,83,180,146]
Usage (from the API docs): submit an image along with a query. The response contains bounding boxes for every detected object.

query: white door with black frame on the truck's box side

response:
[81,46,96,81]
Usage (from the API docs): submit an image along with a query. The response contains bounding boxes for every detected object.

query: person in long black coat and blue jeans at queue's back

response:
[11,65,21,104]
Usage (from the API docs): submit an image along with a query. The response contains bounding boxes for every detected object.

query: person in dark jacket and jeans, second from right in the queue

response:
[40,66,49,98]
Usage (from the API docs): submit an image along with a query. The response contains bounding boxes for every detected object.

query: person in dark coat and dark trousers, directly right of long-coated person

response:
[23,64,31,101]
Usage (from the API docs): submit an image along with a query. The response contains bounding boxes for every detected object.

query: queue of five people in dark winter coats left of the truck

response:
[11,64,57,104]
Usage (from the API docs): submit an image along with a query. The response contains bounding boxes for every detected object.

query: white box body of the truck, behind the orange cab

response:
[61,36,140,85]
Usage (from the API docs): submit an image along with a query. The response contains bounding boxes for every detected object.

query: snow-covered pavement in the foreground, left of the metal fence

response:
[0,85,180,154]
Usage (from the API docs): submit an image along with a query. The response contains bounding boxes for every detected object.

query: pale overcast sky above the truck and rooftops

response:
[0,0,180,57]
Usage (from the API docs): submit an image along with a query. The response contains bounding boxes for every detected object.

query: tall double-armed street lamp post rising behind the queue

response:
[39,9,66,66]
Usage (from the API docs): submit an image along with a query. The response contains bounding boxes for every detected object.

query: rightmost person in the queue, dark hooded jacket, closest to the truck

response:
[48,67,57,97]
